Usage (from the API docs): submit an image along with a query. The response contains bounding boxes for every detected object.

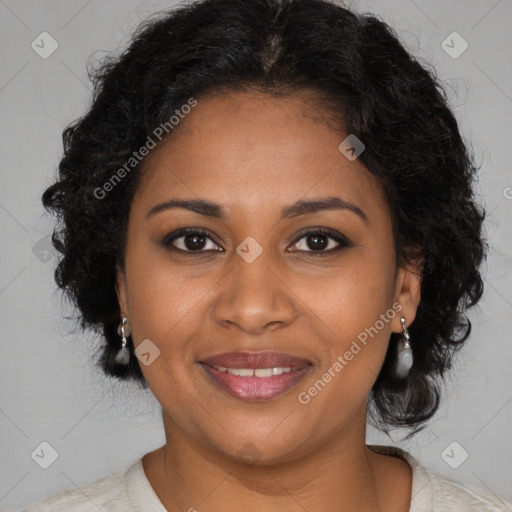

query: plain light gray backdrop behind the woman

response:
[0,0,512,511]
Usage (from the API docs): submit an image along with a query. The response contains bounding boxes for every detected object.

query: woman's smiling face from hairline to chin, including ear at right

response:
[118,93,420,462]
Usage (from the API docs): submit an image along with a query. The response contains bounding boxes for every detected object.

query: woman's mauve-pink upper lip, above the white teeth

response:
[200,351,312,368]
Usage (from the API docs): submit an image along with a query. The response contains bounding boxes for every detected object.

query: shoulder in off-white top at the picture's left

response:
[23,461,136,512]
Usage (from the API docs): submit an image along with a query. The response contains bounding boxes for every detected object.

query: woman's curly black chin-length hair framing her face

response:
[43,0,487,431]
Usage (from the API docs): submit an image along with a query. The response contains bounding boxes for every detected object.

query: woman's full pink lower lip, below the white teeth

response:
[201,363,312,401]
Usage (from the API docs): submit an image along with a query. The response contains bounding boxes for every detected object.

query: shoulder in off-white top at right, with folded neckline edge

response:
[369,445,512,512]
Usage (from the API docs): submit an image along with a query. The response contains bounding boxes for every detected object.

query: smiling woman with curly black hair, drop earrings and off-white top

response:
[23,0,510,512]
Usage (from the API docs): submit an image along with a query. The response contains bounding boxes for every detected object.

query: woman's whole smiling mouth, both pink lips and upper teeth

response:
[199,352,313,401]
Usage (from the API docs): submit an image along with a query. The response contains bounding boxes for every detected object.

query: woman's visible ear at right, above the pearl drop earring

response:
[391,259,424,333]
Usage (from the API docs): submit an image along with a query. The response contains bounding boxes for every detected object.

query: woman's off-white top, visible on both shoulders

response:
[22,445,512,512]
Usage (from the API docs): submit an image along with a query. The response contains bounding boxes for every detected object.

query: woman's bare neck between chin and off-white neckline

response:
[143,413,408,512]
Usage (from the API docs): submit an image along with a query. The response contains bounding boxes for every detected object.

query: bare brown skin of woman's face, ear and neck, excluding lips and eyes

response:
[117,92,421,512]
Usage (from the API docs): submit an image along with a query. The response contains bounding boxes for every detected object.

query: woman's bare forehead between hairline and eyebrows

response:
[136,92,387,220]
